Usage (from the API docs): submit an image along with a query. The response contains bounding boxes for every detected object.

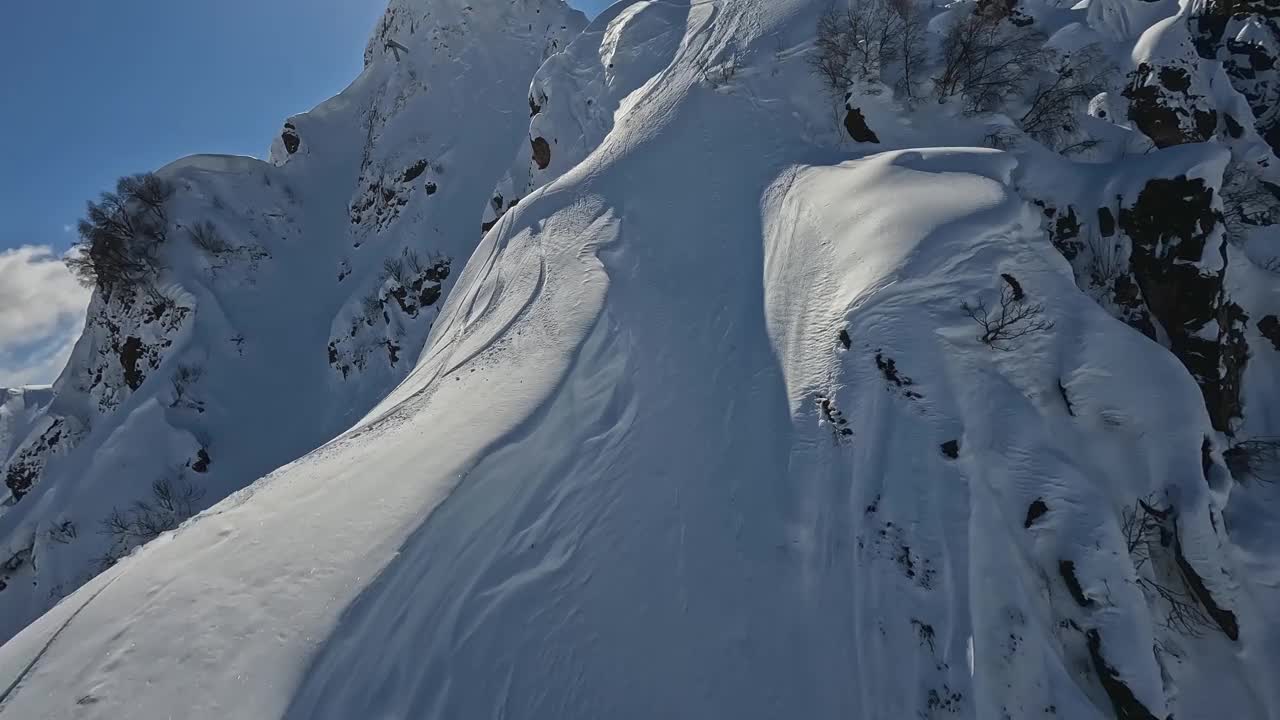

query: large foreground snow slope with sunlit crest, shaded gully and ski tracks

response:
[0,0,1280,719]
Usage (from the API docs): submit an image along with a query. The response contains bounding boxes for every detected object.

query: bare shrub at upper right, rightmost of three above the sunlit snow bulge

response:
[1019,45,1115,152]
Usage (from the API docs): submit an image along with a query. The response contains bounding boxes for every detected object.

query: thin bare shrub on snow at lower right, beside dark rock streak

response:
[1120,497,1216,638]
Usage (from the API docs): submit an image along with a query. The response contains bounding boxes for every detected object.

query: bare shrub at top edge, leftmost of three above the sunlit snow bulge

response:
[810,0,925,101]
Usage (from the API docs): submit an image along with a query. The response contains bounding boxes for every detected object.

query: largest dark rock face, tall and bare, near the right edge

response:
[1120,176,1248,432]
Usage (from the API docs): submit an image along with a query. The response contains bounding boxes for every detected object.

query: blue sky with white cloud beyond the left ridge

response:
[0,0,611,387]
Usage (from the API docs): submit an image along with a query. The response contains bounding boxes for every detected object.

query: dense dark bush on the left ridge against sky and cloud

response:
[67,174,173,291]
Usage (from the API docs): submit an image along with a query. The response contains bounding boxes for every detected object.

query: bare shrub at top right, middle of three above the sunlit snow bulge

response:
[934,13,1053,113]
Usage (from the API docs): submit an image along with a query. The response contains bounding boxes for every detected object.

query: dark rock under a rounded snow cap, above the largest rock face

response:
[1124,63,1217,147]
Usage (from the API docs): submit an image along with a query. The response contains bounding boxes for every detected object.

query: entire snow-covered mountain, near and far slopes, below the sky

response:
[0,0,1280,719]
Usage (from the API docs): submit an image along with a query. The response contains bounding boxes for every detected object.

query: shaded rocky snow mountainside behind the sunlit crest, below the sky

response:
[0,0,585,639]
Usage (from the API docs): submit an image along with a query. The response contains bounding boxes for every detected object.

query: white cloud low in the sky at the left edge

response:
[0,245,90,387]
